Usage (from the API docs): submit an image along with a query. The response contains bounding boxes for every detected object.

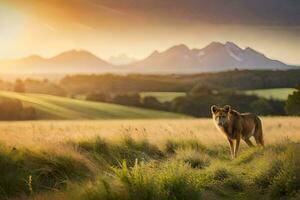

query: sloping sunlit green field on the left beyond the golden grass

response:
[0,91,187,119]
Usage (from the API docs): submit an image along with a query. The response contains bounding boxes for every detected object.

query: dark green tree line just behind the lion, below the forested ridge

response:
[86,85,287,117]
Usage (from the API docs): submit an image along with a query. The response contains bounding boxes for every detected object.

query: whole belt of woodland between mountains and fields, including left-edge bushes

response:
[0,70,300,120]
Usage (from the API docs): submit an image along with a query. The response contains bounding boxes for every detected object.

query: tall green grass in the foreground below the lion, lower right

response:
[83,139,300,200]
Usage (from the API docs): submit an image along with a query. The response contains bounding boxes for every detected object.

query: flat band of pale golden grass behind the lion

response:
[0,117,300,151]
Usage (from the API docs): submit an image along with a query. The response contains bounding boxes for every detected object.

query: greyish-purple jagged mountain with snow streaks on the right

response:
[128,42,288,72]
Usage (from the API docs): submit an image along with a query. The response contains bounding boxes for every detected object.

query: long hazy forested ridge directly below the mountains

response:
[59,70,300,94]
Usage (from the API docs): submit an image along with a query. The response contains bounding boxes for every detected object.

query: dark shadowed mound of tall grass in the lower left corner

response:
[0,144,93,199]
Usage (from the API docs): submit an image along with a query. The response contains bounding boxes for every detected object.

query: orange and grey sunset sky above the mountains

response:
[0,0,300,64]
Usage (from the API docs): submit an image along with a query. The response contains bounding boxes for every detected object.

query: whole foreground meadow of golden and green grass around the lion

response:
[0,117,300,200]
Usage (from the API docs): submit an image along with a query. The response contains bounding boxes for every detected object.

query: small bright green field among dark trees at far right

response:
[246,88,296,100]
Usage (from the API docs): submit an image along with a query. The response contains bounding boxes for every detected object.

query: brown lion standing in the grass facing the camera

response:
[211,105,264,158]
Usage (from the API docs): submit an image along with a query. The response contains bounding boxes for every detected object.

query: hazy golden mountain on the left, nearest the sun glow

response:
[0,50,112,73]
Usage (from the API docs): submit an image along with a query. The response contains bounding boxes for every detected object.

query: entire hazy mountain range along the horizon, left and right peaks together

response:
[0,42,291,74]
